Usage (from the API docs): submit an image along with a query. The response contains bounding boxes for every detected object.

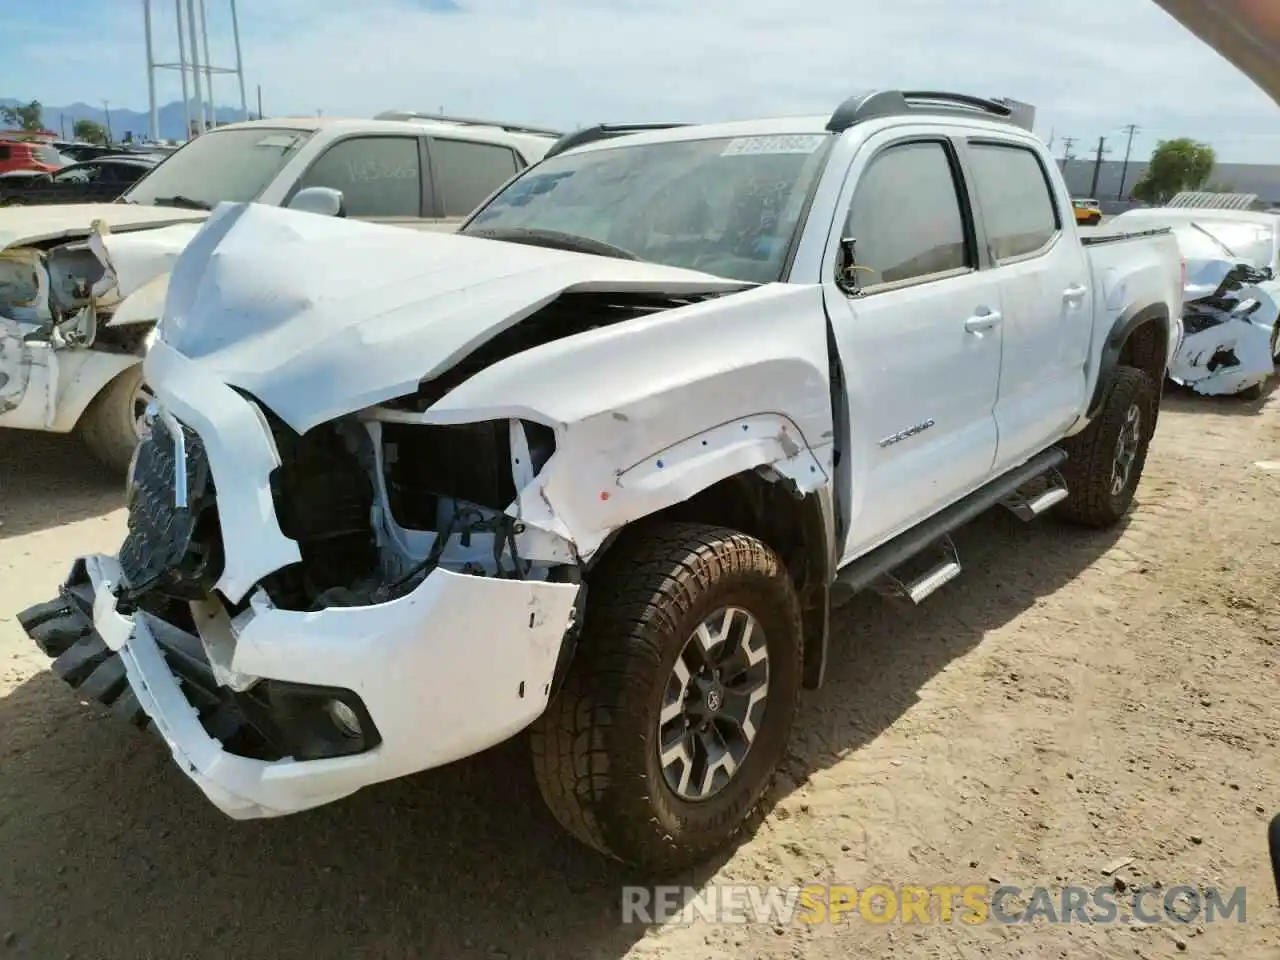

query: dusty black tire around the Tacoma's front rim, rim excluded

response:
[530,524,804,873]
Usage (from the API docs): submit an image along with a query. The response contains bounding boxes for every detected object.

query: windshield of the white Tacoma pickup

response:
[461,133,831,283]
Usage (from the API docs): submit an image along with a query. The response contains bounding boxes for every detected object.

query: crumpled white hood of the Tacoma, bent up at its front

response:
[156,204,755,433]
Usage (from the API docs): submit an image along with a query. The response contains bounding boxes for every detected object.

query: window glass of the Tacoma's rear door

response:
[968,141,1059,264]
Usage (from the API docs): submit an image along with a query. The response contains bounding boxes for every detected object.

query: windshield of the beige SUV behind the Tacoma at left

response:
[122,127,312,210]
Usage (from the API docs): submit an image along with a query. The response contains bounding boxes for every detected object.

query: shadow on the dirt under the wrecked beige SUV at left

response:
[0,430,124,539]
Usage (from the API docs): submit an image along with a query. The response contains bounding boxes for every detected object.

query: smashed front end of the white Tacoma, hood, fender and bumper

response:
[19,205,832,818]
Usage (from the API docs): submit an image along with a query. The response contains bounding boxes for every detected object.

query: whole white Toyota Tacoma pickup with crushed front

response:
[19,91,1181,870]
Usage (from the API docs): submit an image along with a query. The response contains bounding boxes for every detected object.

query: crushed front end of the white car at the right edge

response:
[1169,261,1280,396]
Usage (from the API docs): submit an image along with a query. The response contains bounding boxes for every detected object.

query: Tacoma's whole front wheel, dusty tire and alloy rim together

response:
[531,524,803,872]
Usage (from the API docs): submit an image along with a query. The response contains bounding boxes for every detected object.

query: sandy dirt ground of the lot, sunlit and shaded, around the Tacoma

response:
[0,392,1280,960]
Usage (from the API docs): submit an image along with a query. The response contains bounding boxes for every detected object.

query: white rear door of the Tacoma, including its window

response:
[965,137,1093,472]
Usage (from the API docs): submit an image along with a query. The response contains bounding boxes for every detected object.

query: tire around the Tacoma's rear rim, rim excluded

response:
[1057,366,1160,527]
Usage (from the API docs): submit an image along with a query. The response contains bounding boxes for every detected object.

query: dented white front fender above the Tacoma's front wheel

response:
[425,284,833,559]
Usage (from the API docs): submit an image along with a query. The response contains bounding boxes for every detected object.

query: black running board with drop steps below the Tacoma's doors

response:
[832,447,1066,603]
